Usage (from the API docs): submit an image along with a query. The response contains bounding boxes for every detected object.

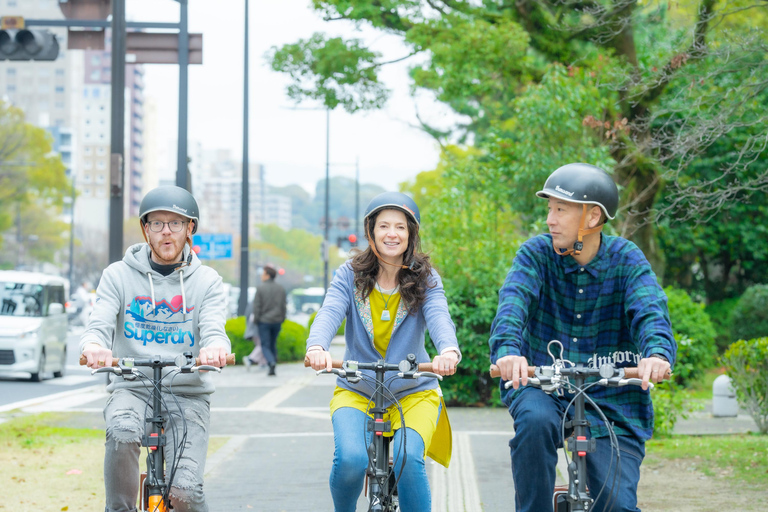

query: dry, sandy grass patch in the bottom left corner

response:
[0,413,229,512]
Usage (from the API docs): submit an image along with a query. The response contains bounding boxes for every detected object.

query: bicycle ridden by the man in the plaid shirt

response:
[490,340,671,512]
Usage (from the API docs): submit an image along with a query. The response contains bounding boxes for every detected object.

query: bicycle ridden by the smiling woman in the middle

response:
[304,354,443,512]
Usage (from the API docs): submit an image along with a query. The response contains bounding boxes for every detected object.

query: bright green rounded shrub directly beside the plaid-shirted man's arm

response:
[664,287,717,384]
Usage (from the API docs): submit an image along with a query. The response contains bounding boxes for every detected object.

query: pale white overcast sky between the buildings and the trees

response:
[126,0,455,192]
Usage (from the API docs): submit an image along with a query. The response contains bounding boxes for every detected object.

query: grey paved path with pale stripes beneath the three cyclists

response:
[4,338,756,512]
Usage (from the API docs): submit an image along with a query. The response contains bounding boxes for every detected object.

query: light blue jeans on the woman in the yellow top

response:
[330,407,432,512]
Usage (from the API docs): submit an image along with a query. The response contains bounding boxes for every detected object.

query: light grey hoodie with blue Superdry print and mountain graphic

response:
[80,243,231,395]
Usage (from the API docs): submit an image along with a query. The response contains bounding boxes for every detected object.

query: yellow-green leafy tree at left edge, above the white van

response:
[0,100,71,265]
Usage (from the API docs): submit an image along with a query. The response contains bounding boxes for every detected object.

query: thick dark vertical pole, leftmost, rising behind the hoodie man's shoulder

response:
[109,0,125,263]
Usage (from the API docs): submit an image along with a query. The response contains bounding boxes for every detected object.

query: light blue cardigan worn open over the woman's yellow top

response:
[307,262,461,406]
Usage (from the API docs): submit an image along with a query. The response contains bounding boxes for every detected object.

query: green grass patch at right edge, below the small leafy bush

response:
[646,434,768,484]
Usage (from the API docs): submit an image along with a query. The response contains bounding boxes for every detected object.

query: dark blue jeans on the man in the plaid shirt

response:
[509,387,645,512]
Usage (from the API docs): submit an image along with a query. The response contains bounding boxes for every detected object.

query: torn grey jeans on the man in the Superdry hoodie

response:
[104,389,211,512]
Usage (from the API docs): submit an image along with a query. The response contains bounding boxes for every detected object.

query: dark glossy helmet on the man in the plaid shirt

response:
[536,163,619,219]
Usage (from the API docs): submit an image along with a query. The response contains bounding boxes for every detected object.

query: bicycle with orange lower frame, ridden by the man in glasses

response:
[80,352,235,512]
